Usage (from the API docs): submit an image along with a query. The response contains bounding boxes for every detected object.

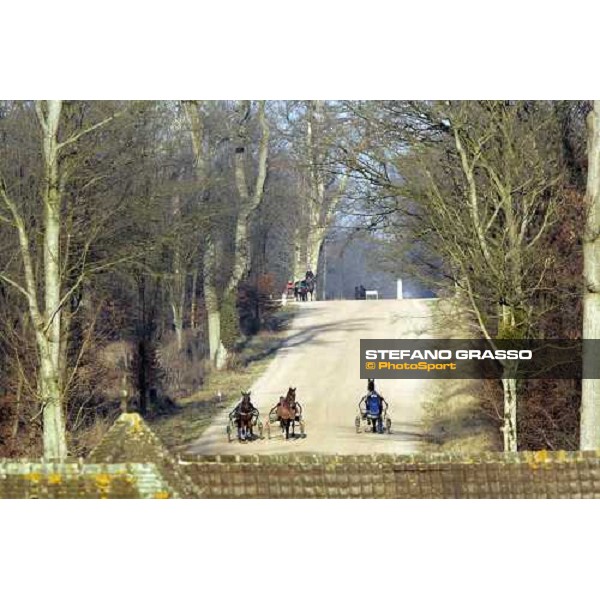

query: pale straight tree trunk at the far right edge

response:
[580,100,600,450]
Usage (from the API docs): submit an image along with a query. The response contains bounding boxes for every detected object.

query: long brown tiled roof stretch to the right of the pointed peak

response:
[182,451,600,498]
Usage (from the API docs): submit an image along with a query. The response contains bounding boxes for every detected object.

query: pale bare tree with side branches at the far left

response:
[0,100,119,460]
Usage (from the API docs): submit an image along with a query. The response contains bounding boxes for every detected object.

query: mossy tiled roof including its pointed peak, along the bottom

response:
[0,414,600,498]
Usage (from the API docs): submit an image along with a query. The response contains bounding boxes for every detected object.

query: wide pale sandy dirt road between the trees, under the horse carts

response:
[190,299,460,454]
